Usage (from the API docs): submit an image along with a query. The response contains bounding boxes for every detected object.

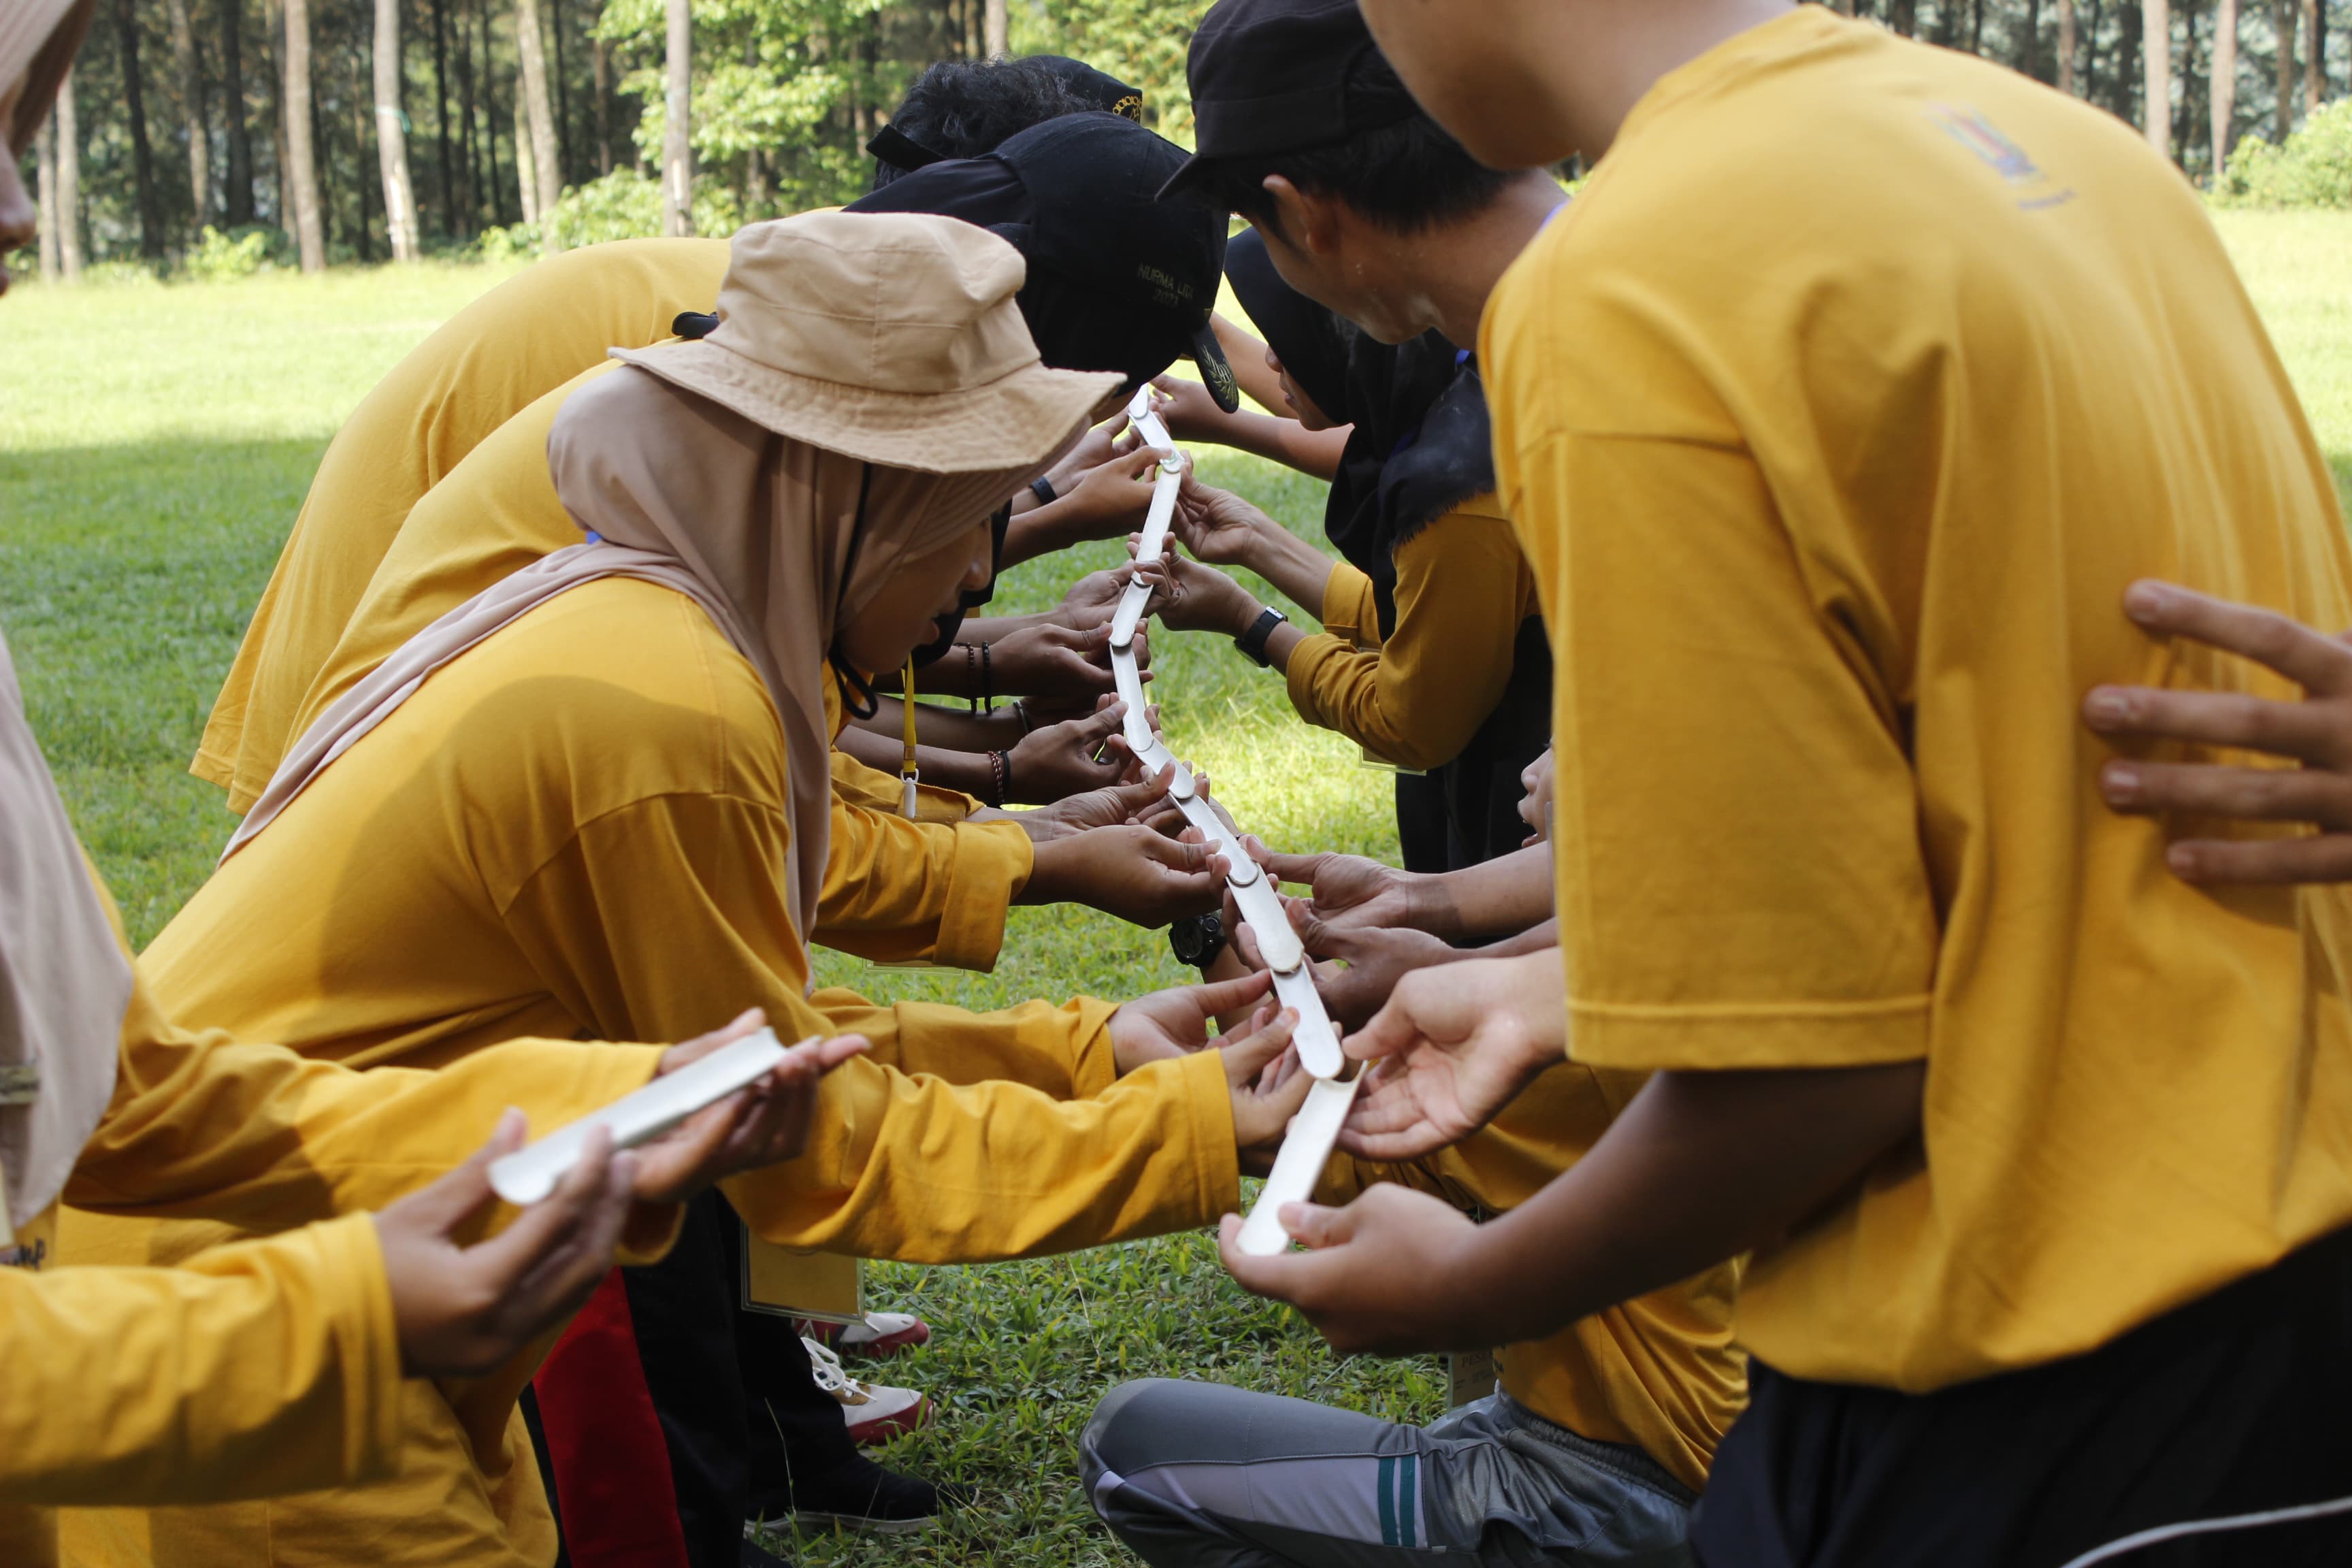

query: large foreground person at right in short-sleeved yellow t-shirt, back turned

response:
[1228,0,2352,1566]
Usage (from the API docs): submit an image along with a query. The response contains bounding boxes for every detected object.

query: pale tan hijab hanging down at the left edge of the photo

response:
[0,642,132,1230]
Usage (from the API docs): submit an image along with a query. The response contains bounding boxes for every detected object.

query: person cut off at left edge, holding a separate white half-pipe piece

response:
[0,27,861,1568]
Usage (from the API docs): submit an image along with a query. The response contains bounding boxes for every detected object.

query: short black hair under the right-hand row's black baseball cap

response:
[1190,50,1510,235]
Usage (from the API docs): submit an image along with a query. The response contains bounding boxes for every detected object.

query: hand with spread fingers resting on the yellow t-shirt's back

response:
[2082,581,2352,884]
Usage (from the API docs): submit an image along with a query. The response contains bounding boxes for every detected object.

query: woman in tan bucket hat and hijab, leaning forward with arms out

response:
[68,214,1303,1563]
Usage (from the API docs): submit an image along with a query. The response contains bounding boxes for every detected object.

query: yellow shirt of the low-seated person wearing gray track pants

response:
[1317,1062,1748,1490]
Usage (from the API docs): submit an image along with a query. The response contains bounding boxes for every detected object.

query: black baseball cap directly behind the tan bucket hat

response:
[847,113,1242,411]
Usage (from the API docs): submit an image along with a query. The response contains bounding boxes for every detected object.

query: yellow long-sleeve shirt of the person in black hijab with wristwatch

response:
[1286,493,1536,769]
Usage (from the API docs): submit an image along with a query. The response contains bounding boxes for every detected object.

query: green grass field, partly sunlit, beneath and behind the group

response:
[0,214,2352,1563]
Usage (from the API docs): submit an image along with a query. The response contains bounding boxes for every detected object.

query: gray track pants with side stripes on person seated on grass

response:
[1084,1377,1693,1568]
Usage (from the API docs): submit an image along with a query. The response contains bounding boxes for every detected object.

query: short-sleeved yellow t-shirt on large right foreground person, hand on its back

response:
[1482,7,2352,1389]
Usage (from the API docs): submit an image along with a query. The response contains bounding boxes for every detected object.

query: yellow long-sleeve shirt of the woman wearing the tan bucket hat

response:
[68,581,1237,1568]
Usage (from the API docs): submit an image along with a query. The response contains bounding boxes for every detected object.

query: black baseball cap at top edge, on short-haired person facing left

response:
[1160,0,1420,200]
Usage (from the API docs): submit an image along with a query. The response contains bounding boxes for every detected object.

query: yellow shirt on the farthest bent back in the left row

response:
[188,240,727,811]
